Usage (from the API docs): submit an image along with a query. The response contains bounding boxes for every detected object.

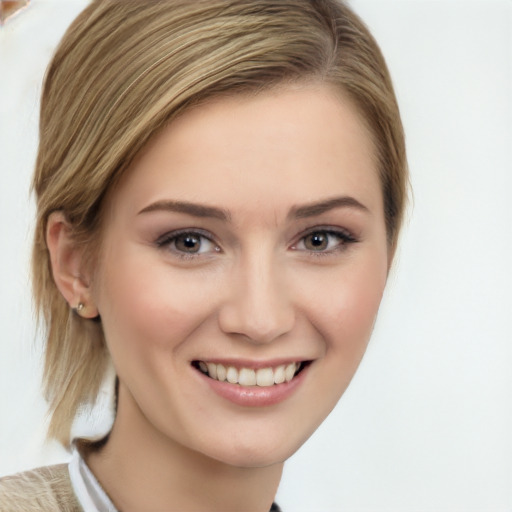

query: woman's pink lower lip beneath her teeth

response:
[196,365,309,407]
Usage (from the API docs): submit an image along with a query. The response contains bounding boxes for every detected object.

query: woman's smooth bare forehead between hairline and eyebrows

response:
[113,85,382,219]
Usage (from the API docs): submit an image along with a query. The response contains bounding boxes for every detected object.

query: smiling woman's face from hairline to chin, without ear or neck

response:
[92,86,389,467]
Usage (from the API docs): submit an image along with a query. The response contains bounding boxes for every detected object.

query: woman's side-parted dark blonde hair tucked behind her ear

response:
[33,0,407,444]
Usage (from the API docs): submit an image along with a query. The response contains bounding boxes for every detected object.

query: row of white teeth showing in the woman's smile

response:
[198,361,300,387]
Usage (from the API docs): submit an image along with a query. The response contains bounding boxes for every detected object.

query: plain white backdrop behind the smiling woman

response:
[0,0,512,512]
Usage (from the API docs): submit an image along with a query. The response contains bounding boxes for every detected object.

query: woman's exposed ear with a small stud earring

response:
[46,211,98,318]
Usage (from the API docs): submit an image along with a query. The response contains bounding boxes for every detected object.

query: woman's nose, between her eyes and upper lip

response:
[218,249,295,344]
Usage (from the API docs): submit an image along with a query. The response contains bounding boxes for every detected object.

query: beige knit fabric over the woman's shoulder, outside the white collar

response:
[0,464,82,512]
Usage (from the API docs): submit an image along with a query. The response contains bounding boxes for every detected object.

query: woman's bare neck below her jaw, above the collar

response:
[86,386,283,512]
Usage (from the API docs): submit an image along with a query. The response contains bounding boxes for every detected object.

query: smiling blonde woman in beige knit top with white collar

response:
[0,0,407,512]
